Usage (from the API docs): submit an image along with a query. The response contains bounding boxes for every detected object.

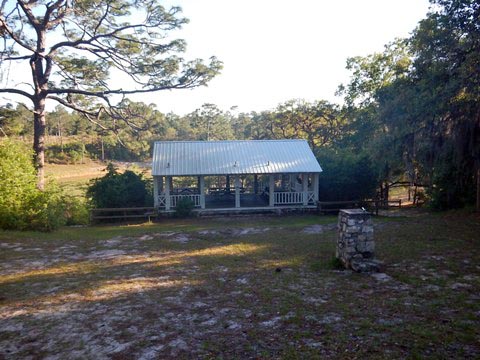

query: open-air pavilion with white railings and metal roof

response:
[152,140,322,212]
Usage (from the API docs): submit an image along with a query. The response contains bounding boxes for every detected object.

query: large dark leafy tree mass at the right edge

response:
[342,0,480,208]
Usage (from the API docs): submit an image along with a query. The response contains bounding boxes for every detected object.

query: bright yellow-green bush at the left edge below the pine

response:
[0,140,66,231]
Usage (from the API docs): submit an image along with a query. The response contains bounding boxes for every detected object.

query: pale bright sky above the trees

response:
[0,0,429,115]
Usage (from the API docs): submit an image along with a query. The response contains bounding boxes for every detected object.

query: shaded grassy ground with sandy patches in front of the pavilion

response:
[0,209,480,359]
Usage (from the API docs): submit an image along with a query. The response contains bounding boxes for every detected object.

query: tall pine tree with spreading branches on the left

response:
[0,0,222,187]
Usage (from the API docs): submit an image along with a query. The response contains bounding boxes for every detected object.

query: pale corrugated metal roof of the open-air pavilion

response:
[152,140,322,176]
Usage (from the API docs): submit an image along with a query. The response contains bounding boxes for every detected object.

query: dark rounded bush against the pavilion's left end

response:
[87,164,153,208]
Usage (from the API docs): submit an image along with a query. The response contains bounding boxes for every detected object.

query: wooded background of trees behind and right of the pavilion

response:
[0,0,480,209]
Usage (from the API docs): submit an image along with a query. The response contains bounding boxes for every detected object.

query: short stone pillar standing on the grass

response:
[336,209,381,272]
